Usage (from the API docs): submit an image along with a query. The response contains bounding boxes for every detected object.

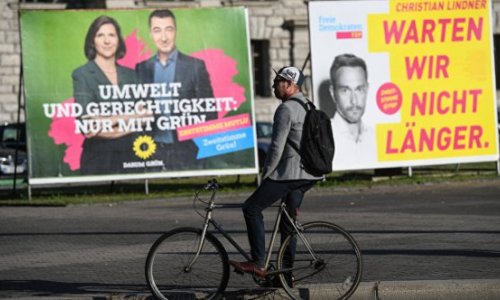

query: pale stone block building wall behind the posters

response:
[0,0,500,122]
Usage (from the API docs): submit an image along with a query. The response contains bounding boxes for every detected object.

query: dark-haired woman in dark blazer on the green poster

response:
[72,16,137,175]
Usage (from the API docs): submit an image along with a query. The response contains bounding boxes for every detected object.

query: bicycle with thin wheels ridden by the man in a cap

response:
[145,179,363,300]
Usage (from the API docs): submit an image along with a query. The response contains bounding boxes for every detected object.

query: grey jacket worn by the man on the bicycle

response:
[263,92,323,181]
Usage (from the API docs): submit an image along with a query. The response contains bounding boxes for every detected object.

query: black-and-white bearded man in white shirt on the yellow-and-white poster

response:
[330,54,377,169]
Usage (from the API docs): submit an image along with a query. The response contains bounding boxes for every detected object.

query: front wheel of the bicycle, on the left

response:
[146,227,229,300]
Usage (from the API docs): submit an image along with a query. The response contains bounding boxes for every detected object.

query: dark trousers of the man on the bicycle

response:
[243,179,316,267]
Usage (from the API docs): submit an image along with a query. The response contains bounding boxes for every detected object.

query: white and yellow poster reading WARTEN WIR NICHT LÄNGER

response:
[309,0,498,171]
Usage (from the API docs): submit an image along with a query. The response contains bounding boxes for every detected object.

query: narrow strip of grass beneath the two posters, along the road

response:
[0,162,498,206]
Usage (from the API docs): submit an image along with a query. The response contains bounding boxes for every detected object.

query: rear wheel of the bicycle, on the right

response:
[277,222,363,300]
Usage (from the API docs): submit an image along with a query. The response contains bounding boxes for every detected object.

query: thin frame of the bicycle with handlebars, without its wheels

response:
[186,184,317,274]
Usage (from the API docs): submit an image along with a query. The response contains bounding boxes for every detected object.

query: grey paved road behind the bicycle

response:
[0,178,500,298]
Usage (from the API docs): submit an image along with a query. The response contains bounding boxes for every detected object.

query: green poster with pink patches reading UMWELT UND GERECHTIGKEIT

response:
[20,8,258,184]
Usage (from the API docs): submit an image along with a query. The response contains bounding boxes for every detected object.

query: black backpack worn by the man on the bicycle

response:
[289,98,335,176]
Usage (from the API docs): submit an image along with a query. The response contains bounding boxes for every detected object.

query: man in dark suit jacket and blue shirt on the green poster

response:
[136,9,217,171]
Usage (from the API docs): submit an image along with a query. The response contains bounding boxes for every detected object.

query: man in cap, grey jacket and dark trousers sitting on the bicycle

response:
[229,67,323,286]
